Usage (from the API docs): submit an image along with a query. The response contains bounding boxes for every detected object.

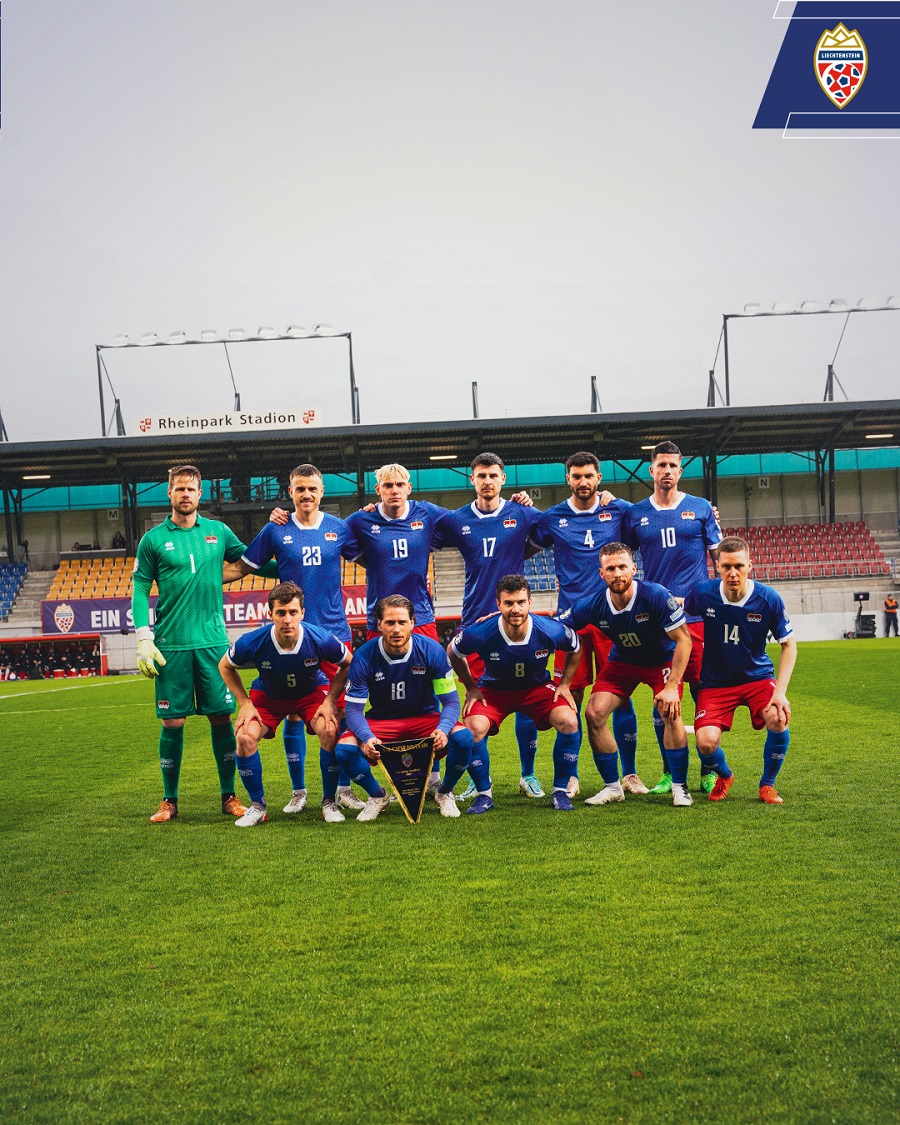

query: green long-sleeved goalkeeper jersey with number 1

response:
[132,516,246,649]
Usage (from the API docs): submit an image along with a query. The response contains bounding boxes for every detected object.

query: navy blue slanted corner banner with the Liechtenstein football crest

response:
[753,0,900,135]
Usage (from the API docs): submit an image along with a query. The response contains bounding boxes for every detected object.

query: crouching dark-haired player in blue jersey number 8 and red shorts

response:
[447,574,582,815]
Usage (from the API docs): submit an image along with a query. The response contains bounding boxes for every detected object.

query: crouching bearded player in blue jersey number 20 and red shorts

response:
[560,543,692,807]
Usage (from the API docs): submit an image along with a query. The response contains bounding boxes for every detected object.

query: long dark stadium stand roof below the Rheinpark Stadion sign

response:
[0,399,900,489]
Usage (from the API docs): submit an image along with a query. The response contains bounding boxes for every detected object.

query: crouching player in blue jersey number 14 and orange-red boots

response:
[684,536,797,804]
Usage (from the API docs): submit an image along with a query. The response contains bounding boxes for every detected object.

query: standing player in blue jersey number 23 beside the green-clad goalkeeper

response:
[235,465,366,813]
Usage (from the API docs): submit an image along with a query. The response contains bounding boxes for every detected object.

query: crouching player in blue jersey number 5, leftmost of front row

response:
[219,582,351,828]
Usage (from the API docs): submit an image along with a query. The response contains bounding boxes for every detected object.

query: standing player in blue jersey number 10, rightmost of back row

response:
[622,441,722,793]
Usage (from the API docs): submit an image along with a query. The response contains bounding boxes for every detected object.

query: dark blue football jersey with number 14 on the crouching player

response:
[684,578,793,687]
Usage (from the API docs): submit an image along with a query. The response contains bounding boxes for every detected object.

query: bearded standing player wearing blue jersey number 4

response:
[531,452,648,797]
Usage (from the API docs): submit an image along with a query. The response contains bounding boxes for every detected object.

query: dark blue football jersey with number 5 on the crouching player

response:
[228,621,347,700]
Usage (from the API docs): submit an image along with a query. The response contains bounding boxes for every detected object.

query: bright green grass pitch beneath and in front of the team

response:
[0,640,900,1123]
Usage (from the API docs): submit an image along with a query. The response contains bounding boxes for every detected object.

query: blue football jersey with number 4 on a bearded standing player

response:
[531,496,631,614]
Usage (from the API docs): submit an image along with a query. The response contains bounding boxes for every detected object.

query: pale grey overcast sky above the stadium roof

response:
[0,0,900,441]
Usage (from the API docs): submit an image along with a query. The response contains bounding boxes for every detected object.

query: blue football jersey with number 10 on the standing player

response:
[622,493,722,621]
